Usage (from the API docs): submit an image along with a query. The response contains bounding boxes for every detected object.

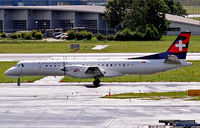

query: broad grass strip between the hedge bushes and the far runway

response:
[0,36,200,53]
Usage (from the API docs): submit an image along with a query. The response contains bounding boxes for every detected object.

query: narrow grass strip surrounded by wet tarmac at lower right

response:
[102,92,200,101]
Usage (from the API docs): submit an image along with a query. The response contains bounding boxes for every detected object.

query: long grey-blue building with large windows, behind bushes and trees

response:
[0,5,200,35]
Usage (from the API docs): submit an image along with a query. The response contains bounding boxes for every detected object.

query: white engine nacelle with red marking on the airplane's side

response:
[66,66,95,78]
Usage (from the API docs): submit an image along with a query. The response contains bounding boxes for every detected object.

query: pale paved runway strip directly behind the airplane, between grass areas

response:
[0,53,200,61]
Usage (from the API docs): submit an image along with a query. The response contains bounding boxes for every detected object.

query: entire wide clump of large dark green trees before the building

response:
[105,0,169,37]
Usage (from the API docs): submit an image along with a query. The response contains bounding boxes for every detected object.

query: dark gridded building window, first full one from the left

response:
[13,20,26,31]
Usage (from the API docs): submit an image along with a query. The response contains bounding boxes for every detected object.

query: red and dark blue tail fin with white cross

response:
[167,32,191,59]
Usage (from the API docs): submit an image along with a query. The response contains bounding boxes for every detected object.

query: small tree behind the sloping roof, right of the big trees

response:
[164,0,187,16]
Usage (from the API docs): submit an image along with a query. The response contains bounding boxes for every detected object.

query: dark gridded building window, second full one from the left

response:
[35,20,50,29]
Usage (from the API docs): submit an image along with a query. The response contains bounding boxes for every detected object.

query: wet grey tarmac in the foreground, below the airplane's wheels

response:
[0,82,200,128]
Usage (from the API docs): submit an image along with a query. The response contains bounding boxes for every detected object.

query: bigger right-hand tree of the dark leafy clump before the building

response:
[124,0,169,35]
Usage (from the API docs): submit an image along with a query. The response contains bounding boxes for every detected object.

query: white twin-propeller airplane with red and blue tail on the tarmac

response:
[5,32,192,87]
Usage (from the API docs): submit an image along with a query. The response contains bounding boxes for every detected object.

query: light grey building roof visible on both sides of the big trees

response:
[0,5,200,25]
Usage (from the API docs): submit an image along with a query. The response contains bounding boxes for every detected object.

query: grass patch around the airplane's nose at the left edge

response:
[0,62,42,83]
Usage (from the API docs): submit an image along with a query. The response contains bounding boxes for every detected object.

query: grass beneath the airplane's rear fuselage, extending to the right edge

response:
[62,61,200,82]
